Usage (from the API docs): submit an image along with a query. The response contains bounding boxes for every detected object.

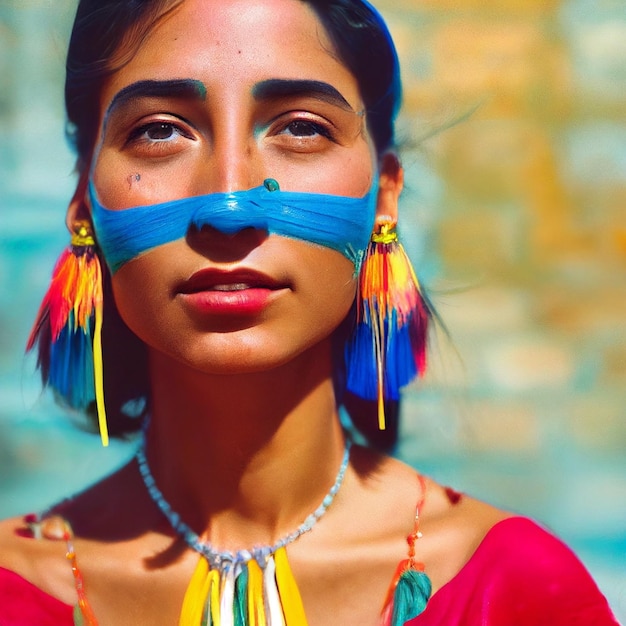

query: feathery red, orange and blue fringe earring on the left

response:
[26,220,109,446]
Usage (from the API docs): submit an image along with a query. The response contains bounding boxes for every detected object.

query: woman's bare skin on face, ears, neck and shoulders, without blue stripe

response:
[0,0,506,626]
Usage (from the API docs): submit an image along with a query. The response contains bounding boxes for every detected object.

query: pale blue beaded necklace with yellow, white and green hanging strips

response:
[136,440,351,626]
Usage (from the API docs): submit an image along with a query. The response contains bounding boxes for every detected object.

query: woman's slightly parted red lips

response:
[176,269,288,315]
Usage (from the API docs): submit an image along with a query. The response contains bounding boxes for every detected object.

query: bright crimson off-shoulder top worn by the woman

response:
[0,517,619,626]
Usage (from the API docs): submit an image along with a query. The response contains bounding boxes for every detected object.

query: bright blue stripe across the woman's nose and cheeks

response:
[89,181,378,273]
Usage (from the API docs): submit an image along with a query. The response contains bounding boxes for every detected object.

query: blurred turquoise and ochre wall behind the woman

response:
[0,0,626,619]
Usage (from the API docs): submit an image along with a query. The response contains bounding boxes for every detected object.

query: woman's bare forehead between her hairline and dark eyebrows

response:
[102,0,360,109]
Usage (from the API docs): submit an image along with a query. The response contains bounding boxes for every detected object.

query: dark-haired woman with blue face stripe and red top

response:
[0,0,616,626]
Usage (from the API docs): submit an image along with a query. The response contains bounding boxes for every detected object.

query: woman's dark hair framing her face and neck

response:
[65,0,401,445]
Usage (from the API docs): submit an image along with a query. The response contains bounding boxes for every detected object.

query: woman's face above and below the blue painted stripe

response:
[92,0,375,372]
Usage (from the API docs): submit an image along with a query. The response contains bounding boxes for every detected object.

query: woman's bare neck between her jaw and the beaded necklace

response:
[142,342,344,549]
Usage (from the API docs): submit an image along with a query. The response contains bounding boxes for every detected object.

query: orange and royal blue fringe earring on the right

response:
[346,222,432,430]
